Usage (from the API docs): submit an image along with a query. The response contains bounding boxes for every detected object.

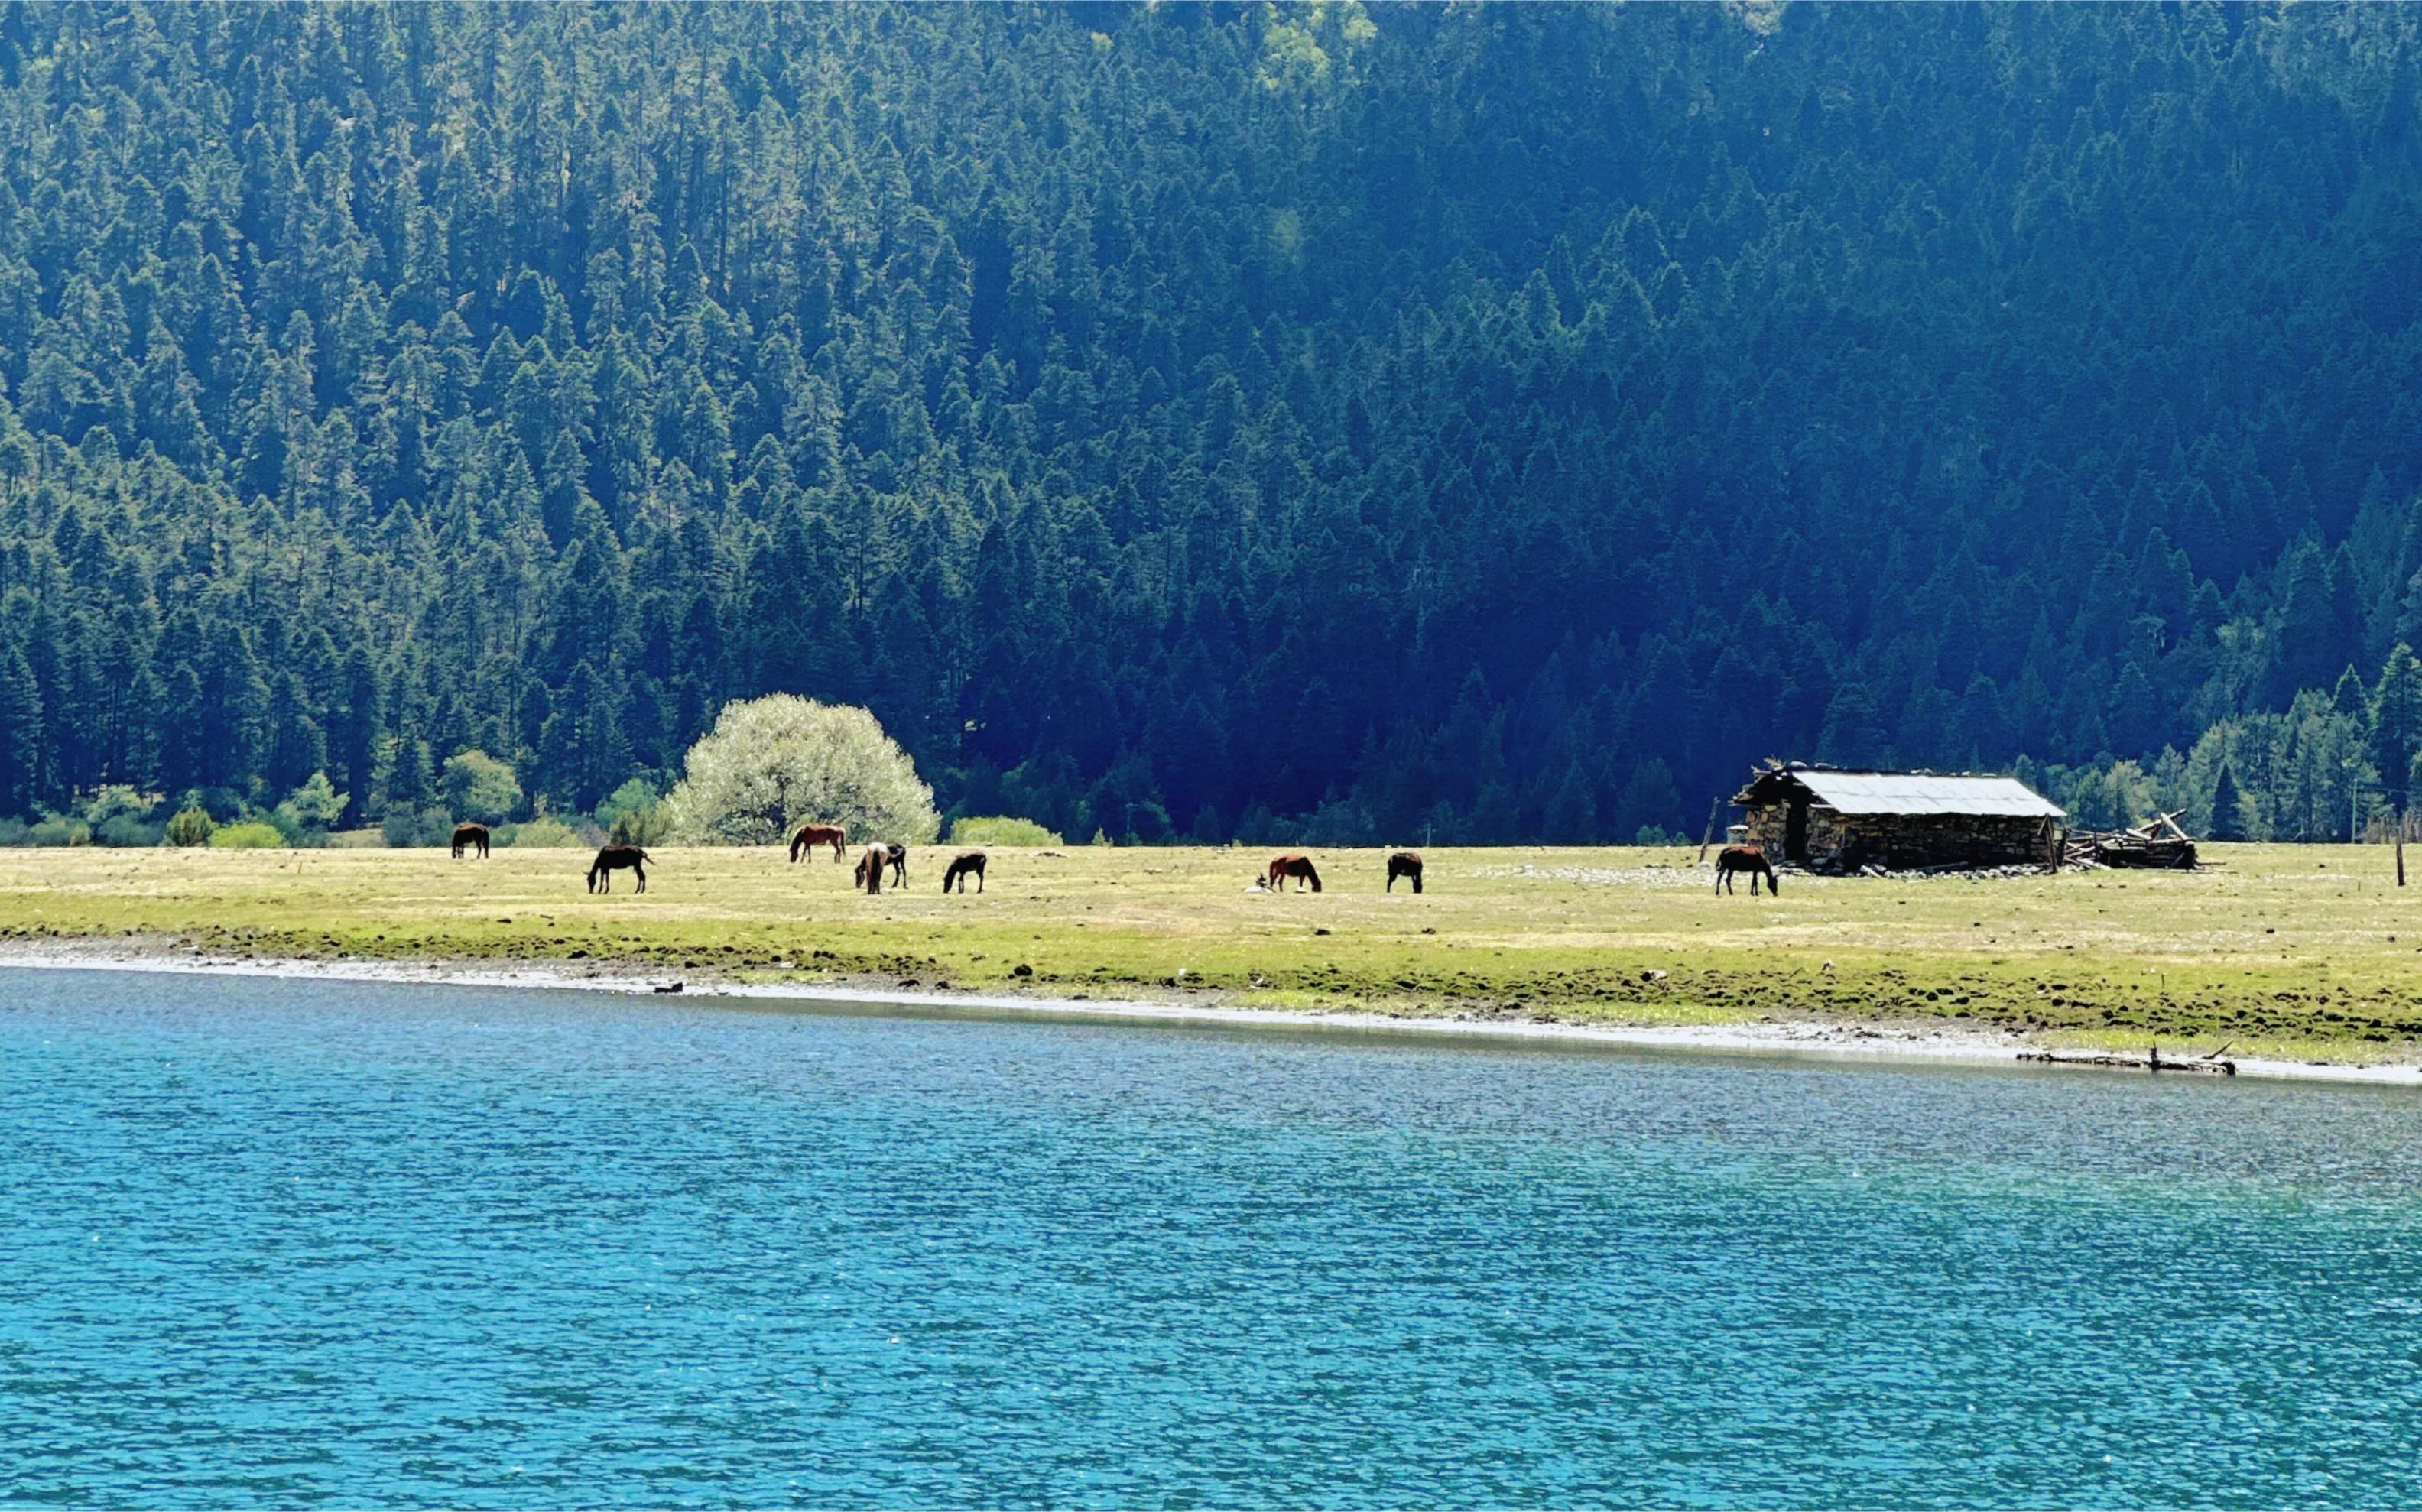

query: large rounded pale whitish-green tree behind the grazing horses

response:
[666,693,942,845]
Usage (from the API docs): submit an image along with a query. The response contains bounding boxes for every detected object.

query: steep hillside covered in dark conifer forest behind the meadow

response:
[0,2,2422,843]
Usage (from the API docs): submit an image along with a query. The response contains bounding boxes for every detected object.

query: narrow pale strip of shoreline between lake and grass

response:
[0,940,2422,1088]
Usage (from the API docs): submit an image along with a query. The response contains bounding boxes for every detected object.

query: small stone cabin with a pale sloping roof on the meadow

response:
[1732,764,2068,872]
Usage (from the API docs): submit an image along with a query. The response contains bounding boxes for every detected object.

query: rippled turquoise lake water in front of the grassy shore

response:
[0,972,2422,1507]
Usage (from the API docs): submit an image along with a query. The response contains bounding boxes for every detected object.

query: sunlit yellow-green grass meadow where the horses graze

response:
[0,845,2422,1059]
